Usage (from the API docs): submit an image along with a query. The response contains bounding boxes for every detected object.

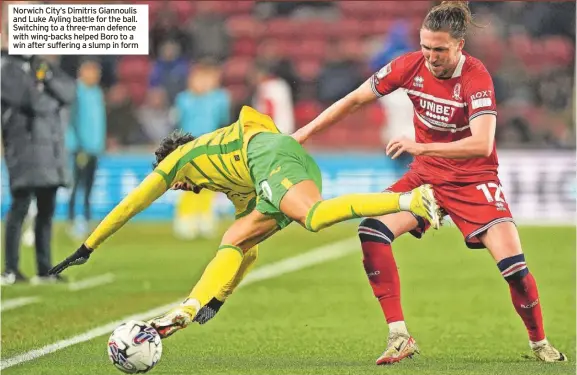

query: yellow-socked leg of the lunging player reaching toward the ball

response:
[150,210,279,338]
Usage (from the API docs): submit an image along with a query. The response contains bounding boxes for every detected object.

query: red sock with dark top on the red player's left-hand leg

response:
[359,219,404,323]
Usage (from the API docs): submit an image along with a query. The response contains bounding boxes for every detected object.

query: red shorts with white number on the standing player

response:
[387,170,513,249]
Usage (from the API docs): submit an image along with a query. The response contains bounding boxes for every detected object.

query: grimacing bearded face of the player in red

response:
[421,29,465,78]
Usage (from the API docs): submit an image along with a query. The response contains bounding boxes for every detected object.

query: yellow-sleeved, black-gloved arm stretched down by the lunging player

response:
[49,173,167,275]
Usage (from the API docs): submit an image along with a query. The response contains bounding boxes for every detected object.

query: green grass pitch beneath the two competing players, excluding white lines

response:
[2,224,576,375]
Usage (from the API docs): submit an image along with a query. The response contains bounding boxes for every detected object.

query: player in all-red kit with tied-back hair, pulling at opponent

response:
[293,1,567,365]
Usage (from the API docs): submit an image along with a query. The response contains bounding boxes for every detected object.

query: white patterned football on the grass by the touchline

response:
[108,320,162,374]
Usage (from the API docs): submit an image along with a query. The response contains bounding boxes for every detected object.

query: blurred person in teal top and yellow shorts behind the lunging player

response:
[174,59,231,239]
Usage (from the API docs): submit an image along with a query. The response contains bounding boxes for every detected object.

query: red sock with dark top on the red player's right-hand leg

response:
[498,254,545,341]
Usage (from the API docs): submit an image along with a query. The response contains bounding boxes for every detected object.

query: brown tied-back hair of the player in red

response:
[422,1,479,39]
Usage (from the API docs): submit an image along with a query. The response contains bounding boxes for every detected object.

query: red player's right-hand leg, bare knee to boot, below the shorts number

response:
[478,221,567,362]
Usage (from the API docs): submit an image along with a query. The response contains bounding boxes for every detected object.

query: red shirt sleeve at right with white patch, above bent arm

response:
[463,71,497,122]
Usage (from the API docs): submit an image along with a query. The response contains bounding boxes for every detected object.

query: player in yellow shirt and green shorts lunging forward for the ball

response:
[50,106,440,338]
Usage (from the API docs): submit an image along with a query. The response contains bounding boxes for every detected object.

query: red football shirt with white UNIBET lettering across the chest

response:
[371,51,498,182]
